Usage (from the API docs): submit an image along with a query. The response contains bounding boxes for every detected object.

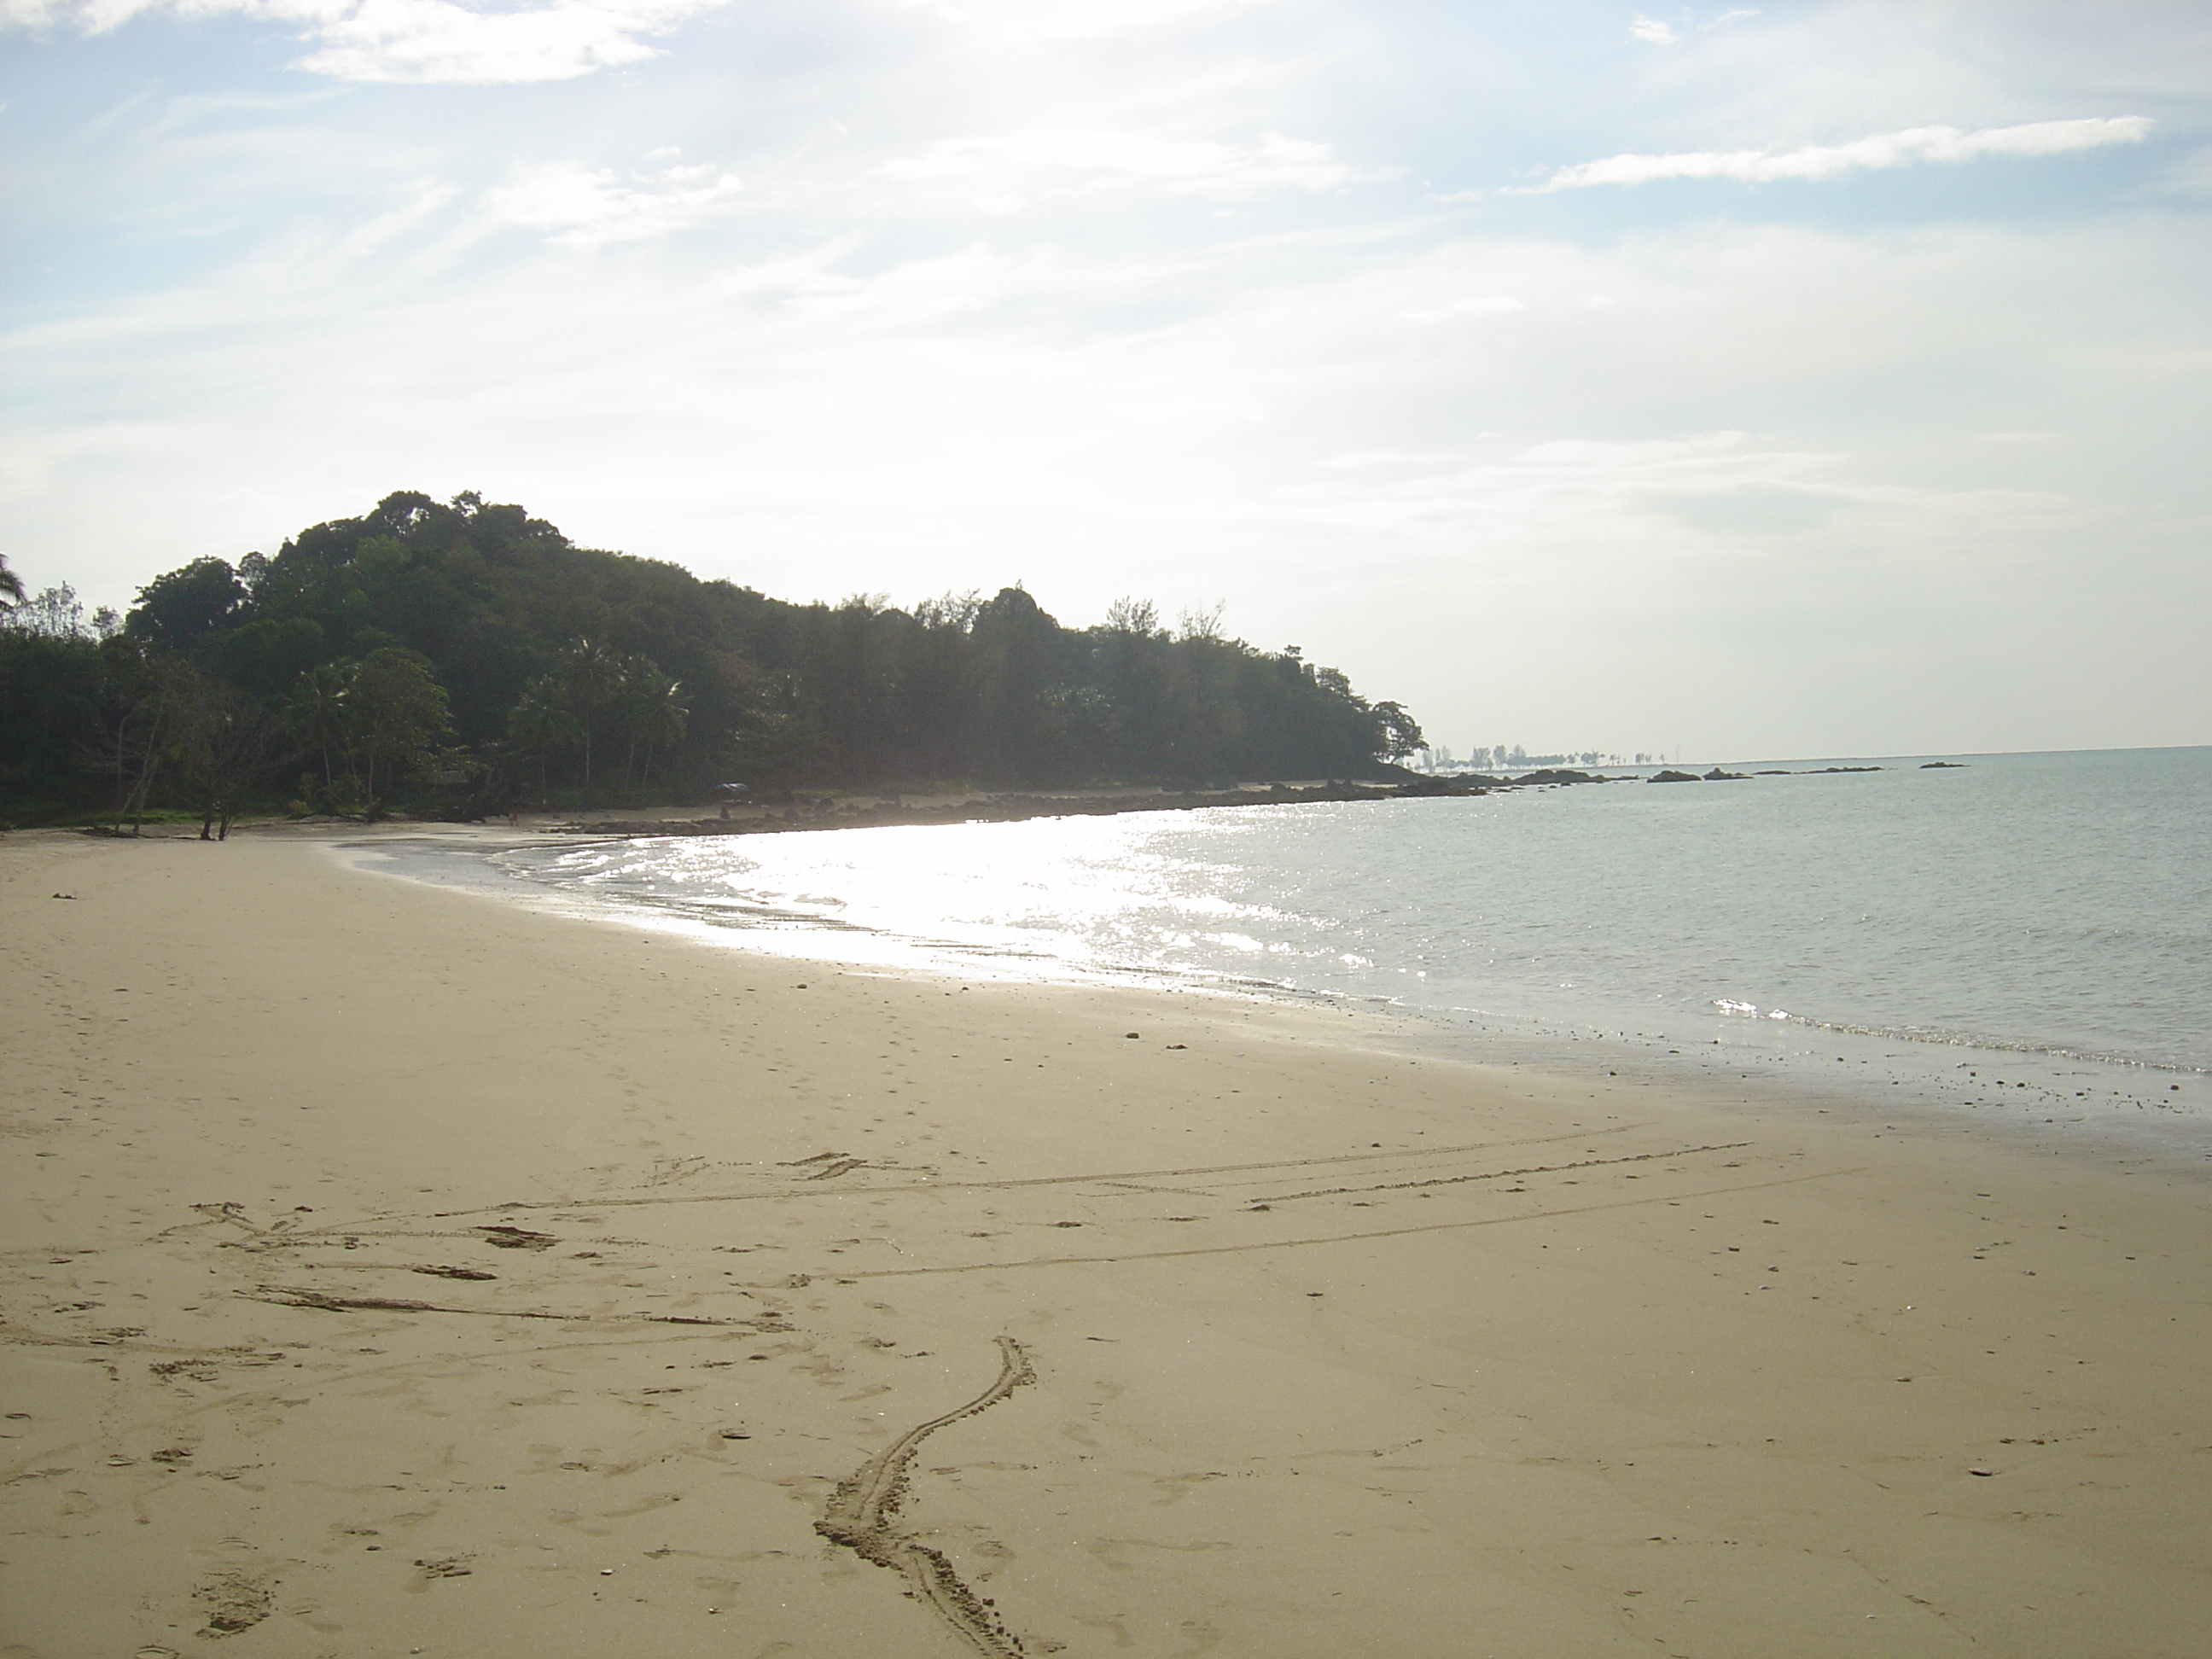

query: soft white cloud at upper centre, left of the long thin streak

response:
[876,128,1382,210]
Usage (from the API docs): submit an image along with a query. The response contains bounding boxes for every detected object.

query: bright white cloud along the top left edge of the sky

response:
[0,0,728,86]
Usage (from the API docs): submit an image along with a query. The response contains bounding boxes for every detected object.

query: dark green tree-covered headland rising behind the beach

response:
[0,491,1423,825]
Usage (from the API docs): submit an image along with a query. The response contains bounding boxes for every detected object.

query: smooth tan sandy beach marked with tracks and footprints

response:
[0,834,2212,1659]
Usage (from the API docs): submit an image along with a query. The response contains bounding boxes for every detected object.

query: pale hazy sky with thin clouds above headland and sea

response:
[0,0,2212,759]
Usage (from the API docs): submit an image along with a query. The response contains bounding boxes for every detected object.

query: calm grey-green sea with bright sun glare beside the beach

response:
[363,748,2212,1159]
